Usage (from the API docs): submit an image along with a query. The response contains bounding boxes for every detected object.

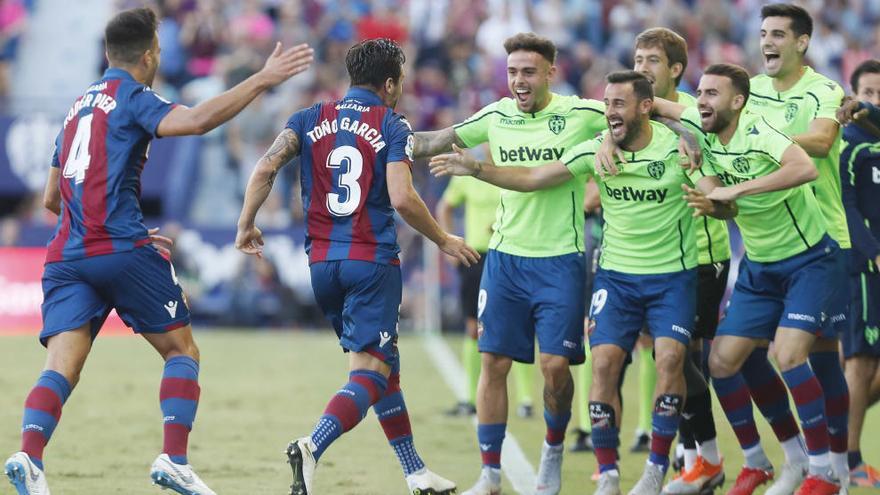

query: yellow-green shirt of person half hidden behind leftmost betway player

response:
[443,177,501,253]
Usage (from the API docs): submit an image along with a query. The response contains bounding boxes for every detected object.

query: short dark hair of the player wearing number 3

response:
[345,38,406,88]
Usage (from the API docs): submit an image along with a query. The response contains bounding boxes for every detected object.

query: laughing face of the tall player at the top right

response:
[761,16,810,78]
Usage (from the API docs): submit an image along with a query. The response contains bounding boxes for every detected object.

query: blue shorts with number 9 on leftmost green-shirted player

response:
[477,250,587,364]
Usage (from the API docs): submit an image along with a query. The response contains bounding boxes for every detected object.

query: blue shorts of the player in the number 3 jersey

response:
[310,260,403,366]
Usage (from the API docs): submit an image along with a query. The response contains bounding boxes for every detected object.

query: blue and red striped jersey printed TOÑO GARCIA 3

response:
[287,88,413,264]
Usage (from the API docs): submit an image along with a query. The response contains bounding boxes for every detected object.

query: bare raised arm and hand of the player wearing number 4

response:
[156,43,314,136]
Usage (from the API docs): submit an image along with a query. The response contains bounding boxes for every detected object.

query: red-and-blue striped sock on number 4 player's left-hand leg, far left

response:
[21,370,71,469]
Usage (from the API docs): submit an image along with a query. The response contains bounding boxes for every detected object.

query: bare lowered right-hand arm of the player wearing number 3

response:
[385,162,480,266]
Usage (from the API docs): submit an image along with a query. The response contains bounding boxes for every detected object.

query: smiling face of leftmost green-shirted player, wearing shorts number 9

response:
[507,50,556,113]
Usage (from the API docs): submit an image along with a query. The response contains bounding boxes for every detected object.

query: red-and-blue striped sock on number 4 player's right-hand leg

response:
[159,356,200,464]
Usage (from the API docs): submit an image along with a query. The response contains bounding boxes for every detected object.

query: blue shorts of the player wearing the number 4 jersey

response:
[40,245,190,345]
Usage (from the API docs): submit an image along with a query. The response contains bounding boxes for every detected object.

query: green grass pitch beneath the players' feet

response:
[0,332,880,495]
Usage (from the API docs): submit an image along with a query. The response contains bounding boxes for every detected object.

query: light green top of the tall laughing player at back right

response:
[746,67,851,248]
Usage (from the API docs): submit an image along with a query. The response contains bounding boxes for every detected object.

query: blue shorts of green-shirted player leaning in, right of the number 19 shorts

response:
[718,235,842,340]
